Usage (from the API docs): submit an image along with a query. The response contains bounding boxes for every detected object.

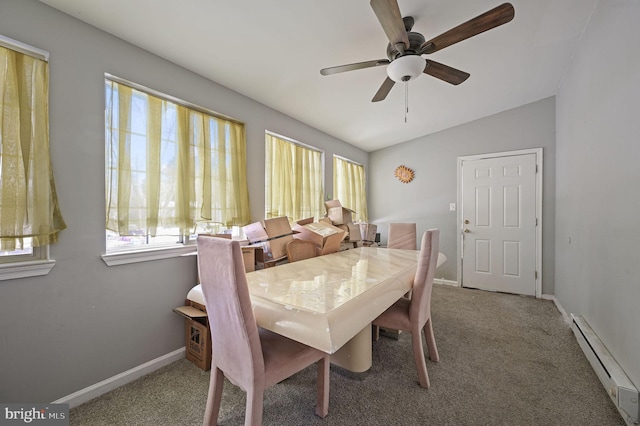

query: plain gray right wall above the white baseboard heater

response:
[556,0,640,387]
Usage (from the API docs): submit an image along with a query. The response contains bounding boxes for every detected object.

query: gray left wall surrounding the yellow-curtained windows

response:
[0,0,368,402]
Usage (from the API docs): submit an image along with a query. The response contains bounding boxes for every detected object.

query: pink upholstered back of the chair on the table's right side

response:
[409,229,440,328]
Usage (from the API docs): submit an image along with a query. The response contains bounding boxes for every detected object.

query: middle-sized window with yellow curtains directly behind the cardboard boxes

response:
[265,132,324,221]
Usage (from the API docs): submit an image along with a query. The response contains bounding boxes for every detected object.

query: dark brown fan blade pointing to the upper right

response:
[420,3,515,54]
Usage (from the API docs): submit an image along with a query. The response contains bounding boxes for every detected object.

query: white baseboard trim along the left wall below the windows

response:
[52,346,185,408]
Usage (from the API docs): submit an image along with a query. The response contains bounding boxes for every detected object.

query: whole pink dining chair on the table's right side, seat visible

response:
[373,229,440,388]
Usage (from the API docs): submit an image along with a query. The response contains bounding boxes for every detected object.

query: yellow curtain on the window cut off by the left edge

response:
[0,46,66,251]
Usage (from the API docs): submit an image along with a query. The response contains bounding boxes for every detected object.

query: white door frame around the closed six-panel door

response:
[456,148,543,299]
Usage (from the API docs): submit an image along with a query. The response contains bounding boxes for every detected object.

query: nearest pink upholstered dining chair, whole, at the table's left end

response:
[198,236,330,426]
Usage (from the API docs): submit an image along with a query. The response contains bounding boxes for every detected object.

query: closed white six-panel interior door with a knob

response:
[461,153,537,296]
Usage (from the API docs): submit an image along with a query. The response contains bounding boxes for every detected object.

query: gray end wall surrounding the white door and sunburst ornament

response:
[368,98,555,294]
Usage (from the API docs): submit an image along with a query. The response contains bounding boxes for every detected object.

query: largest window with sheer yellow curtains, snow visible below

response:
[105,76,250,261]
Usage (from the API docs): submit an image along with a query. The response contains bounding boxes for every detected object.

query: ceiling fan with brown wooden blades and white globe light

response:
[320,0,515,102]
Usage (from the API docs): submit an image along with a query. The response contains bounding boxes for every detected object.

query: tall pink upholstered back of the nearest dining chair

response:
[198,236,264,390]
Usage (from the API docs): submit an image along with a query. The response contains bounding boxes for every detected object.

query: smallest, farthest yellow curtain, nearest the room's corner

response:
[333,156,369,222]
